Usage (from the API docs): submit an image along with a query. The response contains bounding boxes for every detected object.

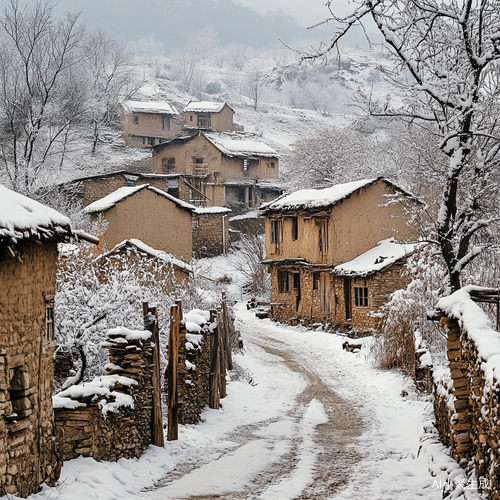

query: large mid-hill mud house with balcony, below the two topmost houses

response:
[152,132,281,207]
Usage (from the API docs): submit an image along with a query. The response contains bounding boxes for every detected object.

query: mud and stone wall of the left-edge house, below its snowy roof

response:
[0,240,61,497]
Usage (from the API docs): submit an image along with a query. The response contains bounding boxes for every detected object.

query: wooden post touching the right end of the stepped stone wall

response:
[142,302,165,447]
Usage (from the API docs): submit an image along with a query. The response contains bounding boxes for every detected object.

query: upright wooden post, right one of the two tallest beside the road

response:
[167,305,180,441]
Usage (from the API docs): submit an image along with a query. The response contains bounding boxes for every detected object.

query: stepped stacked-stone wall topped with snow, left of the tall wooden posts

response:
[54,328,153,462]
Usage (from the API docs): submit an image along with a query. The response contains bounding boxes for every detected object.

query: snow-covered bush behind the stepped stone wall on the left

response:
[55,241,187,386]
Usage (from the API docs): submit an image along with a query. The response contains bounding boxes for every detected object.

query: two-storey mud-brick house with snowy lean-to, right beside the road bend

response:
[261,178,419,330]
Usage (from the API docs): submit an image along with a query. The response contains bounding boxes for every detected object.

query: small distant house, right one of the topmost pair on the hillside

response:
[182,101,234,133]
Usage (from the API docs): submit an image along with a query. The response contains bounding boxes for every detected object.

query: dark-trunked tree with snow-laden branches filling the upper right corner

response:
[304,0,500,291]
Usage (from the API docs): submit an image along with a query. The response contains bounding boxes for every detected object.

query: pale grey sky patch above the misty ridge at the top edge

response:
[233,0,353,26]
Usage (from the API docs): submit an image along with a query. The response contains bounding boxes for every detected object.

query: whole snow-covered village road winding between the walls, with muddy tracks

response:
[24,305,479,500]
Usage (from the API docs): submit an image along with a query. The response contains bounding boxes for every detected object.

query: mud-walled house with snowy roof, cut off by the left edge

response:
[0,186,97,497]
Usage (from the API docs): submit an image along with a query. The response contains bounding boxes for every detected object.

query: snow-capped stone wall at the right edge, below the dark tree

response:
[434,292,500,500]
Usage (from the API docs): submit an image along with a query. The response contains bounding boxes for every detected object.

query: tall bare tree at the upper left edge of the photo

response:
[0,0,84,192]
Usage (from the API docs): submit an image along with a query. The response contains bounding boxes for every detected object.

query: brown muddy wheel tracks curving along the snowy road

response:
[144,335,363,500]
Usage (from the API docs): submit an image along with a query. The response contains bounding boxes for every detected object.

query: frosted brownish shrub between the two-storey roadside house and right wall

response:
[371,246,446,376]
